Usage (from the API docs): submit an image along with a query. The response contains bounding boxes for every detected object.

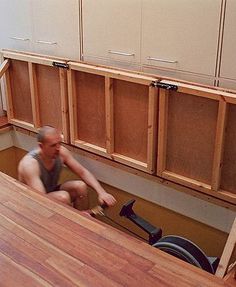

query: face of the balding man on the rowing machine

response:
[39,132,61,159]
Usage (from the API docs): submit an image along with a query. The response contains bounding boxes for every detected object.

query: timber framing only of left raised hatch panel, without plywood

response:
[3,51,69,142]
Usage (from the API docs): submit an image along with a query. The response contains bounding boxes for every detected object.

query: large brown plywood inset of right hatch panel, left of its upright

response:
[166,92,218,184]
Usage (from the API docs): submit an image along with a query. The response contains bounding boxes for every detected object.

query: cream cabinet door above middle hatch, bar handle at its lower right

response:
[82,0,141,63]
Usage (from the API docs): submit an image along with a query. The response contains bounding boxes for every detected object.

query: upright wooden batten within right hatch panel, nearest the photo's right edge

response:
[211,100,228,191]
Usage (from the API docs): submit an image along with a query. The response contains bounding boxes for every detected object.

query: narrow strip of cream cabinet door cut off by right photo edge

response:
[220,0,236,79]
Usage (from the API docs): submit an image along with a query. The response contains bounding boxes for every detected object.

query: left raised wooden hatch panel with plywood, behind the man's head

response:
[3,51,69,142]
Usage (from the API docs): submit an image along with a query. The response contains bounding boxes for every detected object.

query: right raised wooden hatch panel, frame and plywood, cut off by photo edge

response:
[157,81,236,203]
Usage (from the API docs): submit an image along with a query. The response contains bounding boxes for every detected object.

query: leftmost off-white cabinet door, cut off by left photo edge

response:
[0,0,32,51]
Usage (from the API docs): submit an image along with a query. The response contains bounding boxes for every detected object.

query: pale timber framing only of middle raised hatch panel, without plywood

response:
[68,62,158,173]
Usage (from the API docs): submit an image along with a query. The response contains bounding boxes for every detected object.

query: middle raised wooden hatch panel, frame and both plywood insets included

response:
[68,62,158,173]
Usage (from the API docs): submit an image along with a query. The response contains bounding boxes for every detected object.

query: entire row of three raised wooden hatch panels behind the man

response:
[3,51,236,205]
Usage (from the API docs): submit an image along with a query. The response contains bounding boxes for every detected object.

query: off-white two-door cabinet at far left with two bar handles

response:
[0,0,80,60]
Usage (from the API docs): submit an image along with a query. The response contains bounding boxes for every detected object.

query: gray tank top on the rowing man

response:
[29,150,62,192]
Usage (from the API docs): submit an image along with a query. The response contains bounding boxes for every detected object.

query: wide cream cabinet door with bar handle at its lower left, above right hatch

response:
[142,0,221,76]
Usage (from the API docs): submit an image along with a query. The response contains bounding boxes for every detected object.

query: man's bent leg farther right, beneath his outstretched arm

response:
[60,180,89,210]
